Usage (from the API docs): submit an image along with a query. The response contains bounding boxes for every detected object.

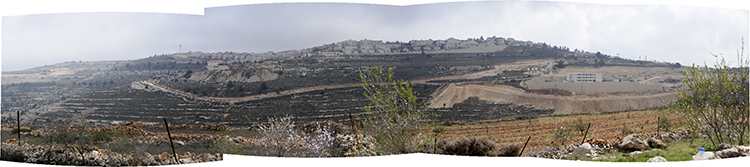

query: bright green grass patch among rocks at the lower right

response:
[593,139,708,162]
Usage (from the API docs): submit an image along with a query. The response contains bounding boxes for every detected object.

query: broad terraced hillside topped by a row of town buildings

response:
[2,35,679,127]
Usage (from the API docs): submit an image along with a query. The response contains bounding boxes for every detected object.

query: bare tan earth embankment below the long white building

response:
[430,84,677,114]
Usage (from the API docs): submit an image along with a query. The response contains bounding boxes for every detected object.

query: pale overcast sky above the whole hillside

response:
[2,1,750,71]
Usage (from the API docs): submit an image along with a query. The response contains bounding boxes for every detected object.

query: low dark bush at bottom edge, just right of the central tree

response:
[437,136,496,156]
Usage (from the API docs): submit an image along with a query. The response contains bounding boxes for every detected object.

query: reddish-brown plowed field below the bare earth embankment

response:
[425,110,686,150]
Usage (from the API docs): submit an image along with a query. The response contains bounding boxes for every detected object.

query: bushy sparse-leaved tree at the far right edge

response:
[671,40,750,147]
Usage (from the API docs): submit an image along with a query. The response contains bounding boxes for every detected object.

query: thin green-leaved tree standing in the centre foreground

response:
[359,67,431,155]
